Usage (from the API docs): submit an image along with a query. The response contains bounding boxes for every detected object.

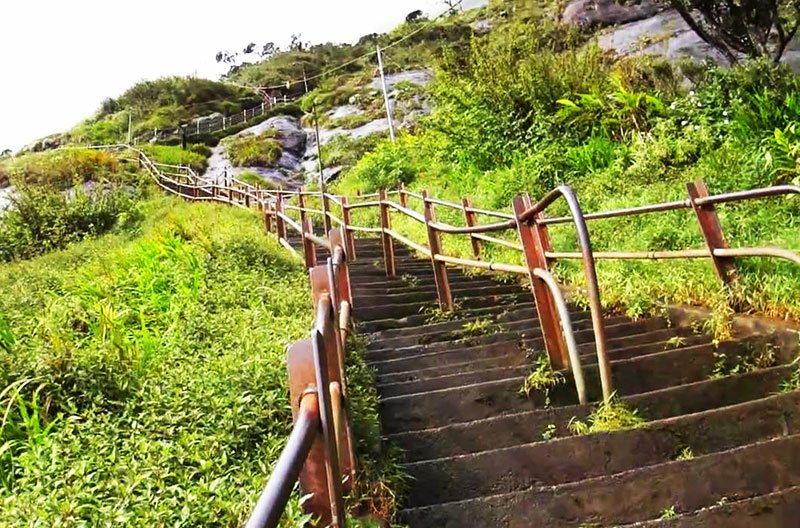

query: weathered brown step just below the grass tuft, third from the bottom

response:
[406,392,800,506]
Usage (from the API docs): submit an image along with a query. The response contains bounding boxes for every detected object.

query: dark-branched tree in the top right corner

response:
[670,0,800,64]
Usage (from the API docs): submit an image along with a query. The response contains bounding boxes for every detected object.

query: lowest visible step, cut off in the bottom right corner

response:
[626,486,800,528]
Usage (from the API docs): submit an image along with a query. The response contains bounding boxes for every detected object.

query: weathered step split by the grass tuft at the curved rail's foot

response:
[382,366,792,442]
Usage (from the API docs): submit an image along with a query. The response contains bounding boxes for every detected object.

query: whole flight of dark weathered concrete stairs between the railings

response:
[320,239,800,528]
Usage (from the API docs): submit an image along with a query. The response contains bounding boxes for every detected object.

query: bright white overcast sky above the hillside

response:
[0,0,483,150]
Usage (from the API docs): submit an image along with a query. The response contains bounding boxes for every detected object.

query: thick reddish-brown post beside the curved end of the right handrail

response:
[513,194,569,370]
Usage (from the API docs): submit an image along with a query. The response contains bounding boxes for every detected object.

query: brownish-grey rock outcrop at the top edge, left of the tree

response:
[561,0,664,28]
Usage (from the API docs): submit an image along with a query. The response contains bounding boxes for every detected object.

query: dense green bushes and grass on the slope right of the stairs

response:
[328,2,800,330]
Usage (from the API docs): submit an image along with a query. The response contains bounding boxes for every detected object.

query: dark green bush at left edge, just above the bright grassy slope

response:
[0,184,140,262]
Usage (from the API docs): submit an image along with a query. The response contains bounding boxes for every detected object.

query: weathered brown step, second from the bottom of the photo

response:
[402,435,800,528]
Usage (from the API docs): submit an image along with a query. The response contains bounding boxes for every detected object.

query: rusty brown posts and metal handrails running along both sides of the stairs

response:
[115,143,800,527]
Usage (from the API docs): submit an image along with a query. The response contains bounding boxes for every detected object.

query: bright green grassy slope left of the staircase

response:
[0,197,354,527]
